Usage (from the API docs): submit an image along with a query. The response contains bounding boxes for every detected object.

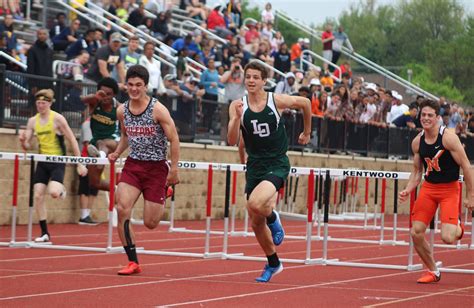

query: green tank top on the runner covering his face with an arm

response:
[91,105,117,144]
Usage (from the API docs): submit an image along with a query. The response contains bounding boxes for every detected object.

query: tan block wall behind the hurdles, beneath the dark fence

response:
[0,131,422,225]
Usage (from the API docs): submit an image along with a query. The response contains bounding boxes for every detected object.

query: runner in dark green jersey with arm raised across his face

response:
[81,78,119,191]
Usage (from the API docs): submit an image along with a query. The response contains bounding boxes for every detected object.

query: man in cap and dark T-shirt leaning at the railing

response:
[86,32,125,87]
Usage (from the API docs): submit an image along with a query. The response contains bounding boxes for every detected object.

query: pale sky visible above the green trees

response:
[249,0,474,25]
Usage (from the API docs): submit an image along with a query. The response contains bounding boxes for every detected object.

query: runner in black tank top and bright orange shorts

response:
[399,100,474,283]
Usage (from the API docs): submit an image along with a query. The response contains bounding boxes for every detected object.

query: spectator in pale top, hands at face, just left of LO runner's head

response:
[220,57,245,143]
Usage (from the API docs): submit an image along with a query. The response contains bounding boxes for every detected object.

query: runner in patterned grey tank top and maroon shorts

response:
[109,65,179,275]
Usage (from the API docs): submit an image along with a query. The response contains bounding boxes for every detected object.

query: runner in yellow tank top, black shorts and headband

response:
[19,89,87,242]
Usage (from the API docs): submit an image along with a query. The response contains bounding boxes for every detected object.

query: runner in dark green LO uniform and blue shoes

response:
[227,62,311,282]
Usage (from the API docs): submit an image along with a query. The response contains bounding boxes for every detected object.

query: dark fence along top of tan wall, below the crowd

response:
[0,65,474,161]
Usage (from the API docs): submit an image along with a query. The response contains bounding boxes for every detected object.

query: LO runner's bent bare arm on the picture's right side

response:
[273,94,311,144]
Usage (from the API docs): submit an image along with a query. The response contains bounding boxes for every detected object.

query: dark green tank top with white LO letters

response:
[241,93,288,162]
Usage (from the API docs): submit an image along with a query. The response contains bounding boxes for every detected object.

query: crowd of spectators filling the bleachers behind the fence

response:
[0,0,474,140]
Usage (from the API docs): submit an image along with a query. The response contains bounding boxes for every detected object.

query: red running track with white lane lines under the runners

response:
[0,219,474,307]
